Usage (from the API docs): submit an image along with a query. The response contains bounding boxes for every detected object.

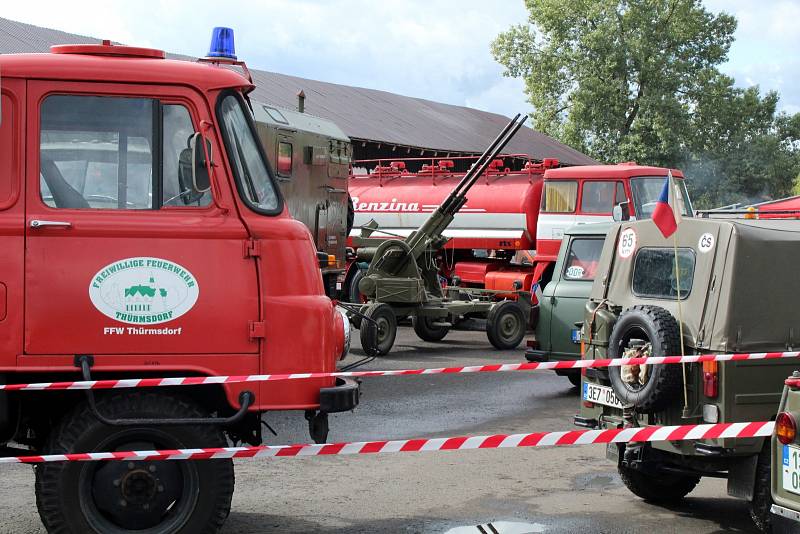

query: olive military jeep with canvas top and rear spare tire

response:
[575,218,800,528]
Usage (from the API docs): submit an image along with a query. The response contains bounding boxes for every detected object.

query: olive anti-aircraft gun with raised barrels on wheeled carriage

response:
[343,114,531,355]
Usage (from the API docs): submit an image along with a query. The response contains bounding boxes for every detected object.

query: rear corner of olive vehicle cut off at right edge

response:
[762,374,800,534]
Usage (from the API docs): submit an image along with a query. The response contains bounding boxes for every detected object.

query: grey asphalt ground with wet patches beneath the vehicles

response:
[0,327,764,534]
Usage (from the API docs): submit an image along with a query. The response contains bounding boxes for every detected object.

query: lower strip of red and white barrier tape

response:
[0,421,775,464]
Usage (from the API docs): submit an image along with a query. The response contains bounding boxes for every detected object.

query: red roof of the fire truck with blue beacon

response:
[0,45,253,91]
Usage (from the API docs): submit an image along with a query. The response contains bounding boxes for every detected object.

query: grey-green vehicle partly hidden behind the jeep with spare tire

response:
[525,223,611,386]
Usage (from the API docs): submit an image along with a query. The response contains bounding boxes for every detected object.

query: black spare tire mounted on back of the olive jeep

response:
[608,306,683,413]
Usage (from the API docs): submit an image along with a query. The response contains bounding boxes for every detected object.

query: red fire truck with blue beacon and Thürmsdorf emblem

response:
[0,29,358,533]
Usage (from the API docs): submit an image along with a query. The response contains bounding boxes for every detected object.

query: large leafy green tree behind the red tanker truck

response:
[492,0,800,206]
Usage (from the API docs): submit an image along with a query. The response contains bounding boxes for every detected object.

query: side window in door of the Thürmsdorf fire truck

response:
[39,95,211,210]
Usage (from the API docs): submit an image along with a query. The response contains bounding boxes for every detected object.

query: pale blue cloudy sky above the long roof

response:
[6,0,800,116]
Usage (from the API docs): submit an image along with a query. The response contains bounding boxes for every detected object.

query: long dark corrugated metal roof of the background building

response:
[0,18,597,165]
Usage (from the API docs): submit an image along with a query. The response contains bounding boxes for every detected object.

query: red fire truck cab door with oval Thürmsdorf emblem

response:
[24,82,258,355]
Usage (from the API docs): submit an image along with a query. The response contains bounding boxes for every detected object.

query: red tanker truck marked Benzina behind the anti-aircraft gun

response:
[345,159,691,300]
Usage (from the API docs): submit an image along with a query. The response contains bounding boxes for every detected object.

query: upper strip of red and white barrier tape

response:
[0,351,800,391]
